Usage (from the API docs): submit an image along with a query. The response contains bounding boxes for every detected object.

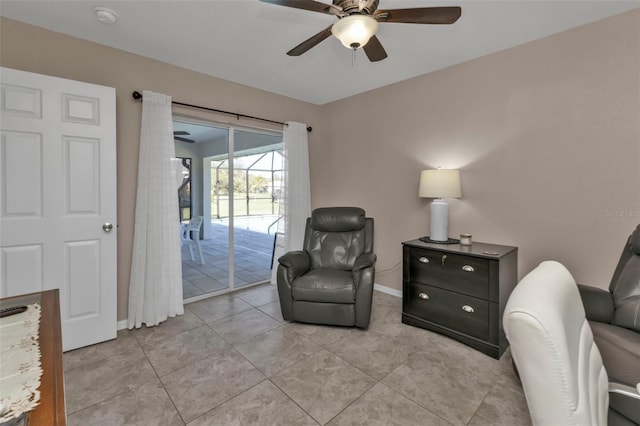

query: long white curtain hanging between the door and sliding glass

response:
[128,91,184,329]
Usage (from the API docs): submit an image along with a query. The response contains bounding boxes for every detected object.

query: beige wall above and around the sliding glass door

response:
[0,18,321,320]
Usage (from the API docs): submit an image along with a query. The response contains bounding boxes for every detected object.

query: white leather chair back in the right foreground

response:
[503,261,609,425]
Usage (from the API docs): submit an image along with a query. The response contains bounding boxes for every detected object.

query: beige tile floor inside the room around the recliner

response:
[64,285,530,426]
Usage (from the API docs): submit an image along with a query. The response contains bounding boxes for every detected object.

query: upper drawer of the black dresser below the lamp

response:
[409,248,491,300]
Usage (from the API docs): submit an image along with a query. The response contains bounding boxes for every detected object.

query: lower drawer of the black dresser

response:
[403,283,492,340]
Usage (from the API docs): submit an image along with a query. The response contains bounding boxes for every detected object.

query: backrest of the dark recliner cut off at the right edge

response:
[609,225,640,331]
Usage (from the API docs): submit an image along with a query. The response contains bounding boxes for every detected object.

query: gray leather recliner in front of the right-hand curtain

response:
[277,207,376,328]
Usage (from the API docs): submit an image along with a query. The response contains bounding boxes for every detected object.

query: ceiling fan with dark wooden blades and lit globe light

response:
[261,0,462,62]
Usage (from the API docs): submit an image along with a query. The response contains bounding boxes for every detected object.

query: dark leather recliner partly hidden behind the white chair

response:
[578,225,640,385]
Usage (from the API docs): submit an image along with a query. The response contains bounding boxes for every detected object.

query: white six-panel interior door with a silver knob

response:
[0,68,117,351]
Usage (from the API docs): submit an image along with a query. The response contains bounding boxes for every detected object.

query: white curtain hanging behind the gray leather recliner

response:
[271,121,311,284]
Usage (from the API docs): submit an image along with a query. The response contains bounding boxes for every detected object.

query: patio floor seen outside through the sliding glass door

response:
[182,223,274,299]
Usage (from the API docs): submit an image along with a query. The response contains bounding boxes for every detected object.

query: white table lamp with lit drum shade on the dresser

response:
[418,169,462,242]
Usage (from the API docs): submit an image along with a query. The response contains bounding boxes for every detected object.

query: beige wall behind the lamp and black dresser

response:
[320,11,640,288]
